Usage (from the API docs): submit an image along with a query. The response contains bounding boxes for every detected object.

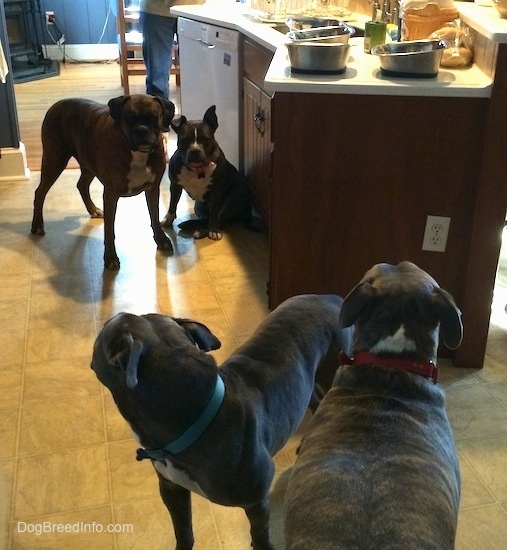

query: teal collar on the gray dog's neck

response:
[136,374,225,460]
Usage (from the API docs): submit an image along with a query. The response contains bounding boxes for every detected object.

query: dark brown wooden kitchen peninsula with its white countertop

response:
[173,3,507,368]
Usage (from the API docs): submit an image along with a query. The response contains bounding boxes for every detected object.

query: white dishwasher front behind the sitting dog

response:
[178,17,242,169]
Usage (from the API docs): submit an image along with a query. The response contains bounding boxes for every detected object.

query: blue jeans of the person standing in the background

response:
[139,12,176,99]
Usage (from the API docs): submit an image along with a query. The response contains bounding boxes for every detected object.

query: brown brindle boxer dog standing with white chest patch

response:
[31,94,175,271]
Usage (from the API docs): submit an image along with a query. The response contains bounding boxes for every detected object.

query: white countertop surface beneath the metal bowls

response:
[171,2,500,98]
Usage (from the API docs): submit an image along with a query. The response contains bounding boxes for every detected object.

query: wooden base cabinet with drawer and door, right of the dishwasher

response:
[243,39,273,227]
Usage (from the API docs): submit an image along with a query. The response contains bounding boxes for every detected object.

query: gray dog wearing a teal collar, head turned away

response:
[91,295,352,550]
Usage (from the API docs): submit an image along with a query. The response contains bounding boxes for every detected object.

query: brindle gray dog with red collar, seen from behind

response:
[285,262,462,550]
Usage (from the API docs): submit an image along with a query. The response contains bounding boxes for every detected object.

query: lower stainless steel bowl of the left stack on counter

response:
[287,41,350,74]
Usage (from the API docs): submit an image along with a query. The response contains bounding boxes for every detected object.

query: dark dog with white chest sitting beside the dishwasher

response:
[162,105,252,241]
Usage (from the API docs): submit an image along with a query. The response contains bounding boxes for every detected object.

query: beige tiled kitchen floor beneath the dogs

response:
[0,163,507,550]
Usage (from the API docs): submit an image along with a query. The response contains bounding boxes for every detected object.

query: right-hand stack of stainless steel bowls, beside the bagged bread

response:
[371,39,447,78]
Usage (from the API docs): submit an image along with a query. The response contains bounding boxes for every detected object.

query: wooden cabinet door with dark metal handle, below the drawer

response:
[243,78,272,227]
